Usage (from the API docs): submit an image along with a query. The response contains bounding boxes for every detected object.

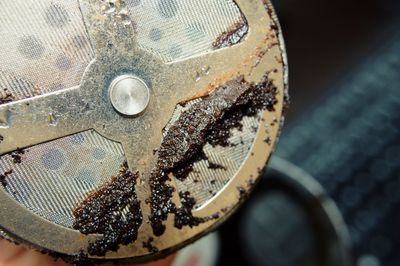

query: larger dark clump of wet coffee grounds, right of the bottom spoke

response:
[147,72,278,236]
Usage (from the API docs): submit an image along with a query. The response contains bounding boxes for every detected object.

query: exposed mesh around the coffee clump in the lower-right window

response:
[164,99,261,208]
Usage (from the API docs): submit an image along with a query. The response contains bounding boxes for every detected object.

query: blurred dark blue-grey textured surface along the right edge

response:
[278,27,400,266]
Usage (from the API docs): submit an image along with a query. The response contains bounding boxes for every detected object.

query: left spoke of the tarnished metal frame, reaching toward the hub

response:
[0,88,95,154]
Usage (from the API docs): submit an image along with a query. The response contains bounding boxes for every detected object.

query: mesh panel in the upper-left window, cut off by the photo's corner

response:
[0,0,94,99]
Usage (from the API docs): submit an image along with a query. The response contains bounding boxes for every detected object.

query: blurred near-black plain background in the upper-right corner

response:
[272,0,400,119]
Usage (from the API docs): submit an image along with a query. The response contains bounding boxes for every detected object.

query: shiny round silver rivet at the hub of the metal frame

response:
[110,75,150,116]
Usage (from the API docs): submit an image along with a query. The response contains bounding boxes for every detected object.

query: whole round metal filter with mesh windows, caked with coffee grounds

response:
[0,0,288,265]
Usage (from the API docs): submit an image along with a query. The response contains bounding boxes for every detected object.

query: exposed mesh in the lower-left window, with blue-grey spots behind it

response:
[0,131,125,227]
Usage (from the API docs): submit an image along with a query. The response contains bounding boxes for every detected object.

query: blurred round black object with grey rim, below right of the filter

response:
[218,157,351,266]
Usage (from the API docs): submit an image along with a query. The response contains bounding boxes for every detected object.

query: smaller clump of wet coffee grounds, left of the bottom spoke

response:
[73,162,143,256]
